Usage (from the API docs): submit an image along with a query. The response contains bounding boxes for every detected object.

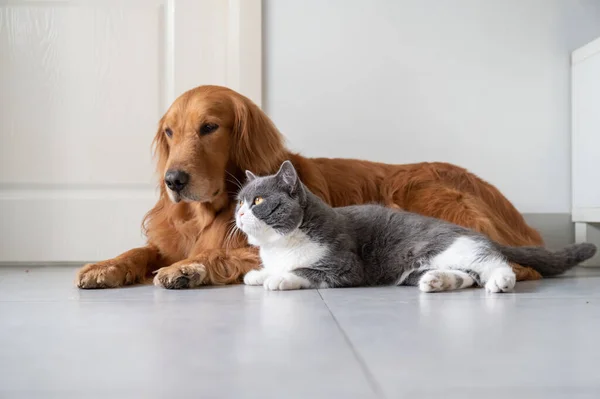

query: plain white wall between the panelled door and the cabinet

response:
[264,0,600,213]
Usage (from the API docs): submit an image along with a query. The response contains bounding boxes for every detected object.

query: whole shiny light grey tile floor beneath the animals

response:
[0,266,600,399]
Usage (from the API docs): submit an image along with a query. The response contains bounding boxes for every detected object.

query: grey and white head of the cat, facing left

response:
[235,161,306,245]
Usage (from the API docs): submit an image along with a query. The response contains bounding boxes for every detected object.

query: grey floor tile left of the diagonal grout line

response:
[0,269,373,398]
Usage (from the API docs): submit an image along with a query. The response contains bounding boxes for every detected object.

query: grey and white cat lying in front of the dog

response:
[235,161,596,292]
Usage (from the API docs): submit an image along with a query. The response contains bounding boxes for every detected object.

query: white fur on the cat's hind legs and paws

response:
[419,237,516,292]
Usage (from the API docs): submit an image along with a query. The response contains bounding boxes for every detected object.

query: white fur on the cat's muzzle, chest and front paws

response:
[236,203,327,290]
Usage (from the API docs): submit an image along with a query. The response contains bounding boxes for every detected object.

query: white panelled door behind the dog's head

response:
[0,0,261,262]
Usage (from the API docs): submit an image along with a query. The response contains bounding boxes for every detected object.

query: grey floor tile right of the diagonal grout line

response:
[320,272,600,398]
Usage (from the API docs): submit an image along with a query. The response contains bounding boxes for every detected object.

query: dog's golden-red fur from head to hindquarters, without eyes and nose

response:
[76,86,543,288]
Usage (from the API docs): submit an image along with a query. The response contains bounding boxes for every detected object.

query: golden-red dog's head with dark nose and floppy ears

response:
[154,86,285,202]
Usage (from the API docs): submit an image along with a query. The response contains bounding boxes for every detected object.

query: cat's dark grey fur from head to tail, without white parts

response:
[238,161,596,287]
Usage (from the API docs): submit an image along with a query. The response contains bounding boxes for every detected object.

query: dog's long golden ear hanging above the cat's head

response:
[231,93,286,176]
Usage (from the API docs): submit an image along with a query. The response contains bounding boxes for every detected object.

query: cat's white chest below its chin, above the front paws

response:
[260,230,327,273]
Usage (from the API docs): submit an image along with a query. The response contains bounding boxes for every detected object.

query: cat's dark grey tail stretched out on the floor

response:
[498,243,596,277]
